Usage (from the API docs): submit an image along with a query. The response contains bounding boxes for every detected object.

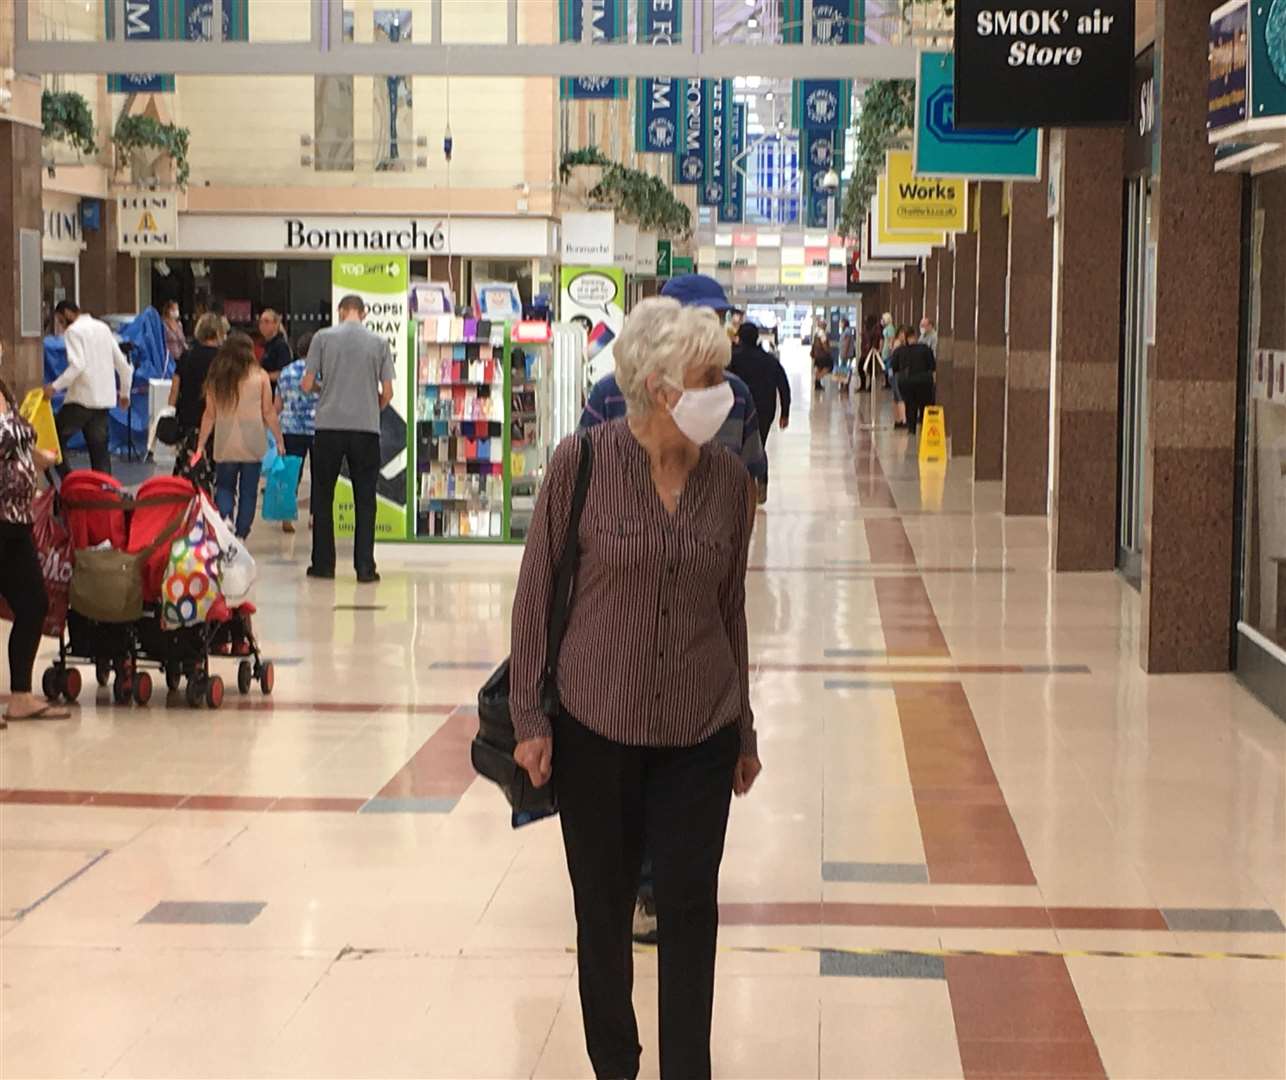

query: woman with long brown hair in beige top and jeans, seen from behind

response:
[197,334,285,540]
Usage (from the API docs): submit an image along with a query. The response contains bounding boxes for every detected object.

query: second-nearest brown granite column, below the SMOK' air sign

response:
[1051,128,1126,570]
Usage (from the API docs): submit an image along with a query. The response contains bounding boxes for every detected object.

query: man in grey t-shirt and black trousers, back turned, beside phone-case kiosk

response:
[300,296,394,582]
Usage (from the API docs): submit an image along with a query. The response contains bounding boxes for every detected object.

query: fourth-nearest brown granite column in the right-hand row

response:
[974,180,1010,480]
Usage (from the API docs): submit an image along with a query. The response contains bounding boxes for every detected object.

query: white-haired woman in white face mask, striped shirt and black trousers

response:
[509,298,760,1080]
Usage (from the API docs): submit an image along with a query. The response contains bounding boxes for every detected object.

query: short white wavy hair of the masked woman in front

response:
[612,297,732,415]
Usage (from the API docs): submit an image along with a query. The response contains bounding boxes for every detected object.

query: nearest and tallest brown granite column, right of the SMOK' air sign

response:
[1141,0,1241,671]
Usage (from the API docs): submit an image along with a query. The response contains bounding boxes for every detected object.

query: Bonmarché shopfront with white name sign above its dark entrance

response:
[139,213,557,339]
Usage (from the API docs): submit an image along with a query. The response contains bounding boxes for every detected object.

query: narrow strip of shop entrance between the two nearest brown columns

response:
[1116,175,1156,589]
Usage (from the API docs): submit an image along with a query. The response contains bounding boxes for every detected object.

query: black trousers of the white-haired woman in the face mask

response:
[554,715,741,1080]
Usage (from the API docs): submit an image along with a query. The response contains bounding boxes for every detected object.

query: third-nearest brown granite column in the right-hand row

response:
[1004,153,1053,516]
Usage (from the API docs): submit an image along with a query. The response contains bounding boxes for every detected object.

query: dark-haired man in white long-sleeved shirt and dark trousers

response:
[45,300,134,476]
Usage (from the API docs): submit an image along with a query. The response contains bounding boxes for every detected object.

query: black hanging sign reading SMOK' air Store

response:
[954,0,1134,129]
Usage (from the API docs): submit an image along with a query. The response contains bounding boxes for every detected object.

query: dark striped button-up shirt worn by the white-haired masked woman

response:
[509,420,755,752]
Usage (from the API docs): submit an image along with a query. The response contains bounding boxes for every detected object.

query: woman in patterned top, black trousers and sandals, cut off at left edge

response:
[0,348,71,728]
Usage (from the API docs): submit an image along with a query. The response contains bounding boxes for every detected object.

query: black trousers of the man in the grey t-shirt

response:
[312,429,379,573]
